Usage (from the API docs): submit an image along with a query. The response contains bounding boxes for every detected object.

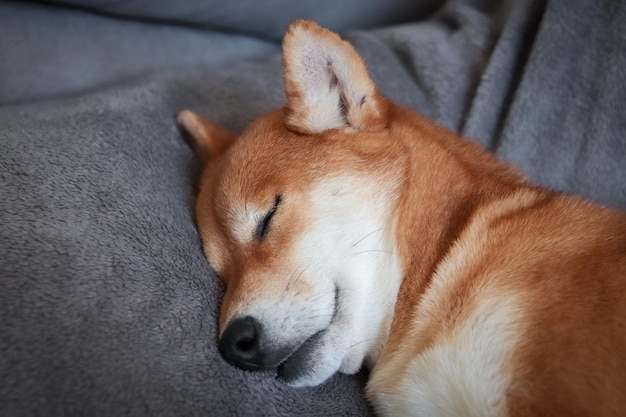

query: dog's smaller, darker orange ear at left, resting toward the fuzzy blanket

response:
[176,110,235,164]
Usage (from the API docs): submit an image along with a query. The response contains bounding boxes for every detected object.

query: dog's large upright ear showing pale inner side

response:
[283,20,388,134]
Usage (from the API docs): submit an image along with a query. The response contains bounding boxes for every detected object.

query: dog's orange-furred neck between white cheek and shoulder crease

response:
[378,108,529,358]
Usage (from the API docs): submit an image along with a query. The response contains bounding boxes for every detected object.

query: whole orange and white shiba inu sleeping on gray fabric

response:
[179,21,626,416]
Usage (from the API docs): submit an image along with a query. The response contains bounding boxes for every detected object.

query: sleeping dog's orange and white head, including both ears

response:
[178,21,403,386]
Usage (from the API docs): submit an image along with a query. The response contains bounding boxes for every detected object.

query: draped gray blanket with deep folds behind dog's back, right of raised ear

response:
[349,0,626,208]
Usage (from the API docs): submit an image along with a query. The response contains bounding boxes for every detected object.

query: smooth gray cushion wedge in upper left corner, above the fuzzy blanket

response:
[0,2,280,105]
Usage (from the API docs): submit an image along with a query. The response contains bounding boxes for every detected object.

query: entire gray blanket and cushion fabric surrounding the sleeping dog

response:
[0,0,626,417]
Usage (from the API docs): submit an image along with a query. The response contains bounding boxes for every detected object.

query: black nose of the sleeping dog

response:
[219,316,266,371]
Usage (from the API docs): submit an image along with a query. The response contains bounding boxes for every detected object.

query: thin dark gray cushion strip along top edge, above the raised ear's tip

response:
[42,0,441,40]
